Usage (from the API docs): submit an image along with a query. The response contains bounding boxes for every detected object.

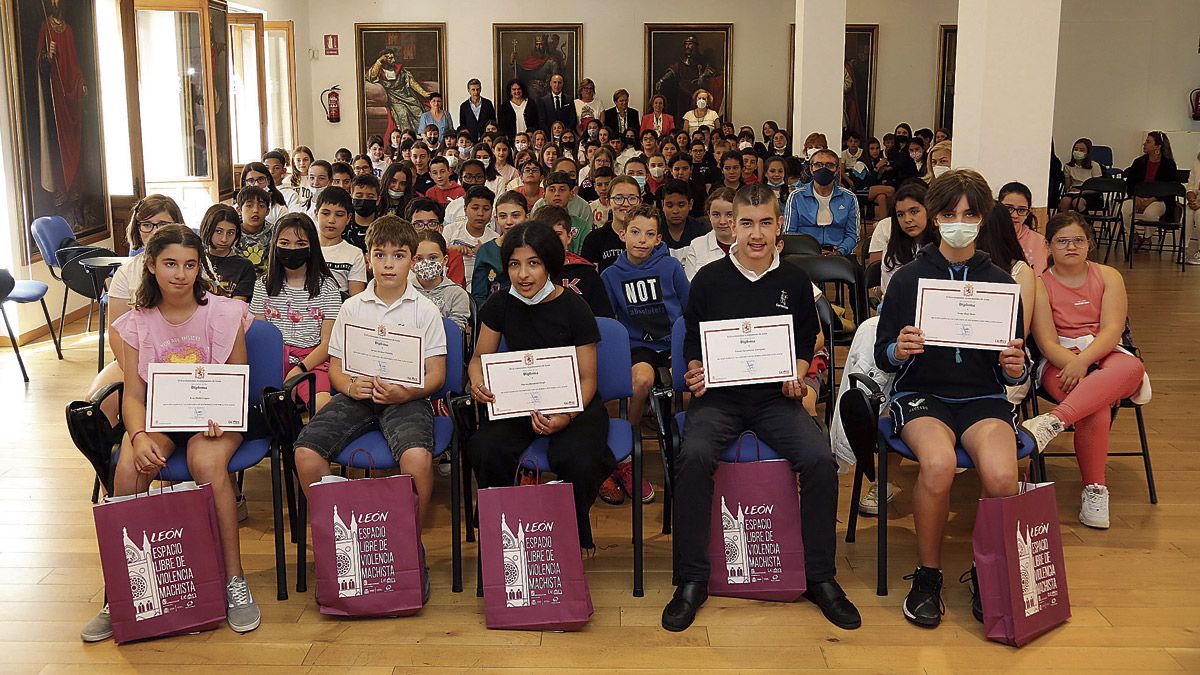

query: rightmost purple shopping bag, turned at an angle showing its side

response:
[972,483,1070,647]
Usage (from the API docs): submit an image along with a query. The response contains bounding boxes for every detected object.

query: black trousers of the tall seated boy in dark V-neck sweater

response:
[673,387,838,585]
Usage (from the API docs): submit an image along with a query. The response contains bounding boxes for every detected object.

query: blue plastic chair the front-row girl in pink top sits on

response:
[81,321,288,601]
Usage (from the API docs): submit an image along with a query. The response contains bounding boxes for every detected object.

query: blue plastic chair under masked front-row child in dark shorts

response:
[838,372,1038,596]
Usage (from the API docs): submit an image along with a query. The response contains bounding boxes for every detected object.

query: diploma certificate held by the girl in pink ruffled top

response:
[146,363,250,431]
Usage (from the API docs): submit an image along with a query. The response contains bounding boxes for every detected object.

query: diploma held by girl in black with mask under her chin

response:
[480,347,583,419]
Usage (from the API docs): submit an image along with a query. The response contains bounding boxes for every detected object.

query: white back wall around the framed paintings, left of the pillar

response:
[296,0,794,156]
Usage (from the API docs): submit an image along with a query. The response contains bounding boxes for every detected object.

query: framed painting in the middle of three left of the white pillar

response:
[492,24,583,106]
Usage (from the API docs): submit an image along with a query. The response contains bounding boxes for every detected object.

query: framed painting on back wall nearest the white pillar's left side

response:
[644,24,733,124]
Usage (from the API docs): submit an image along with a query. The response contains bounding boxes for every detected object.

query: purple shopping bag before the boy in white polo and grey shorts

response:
[308,476,425,616]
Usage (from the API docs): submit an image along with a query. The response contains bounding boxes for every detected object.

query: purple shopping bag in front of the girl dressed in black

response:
[478,482,592,631]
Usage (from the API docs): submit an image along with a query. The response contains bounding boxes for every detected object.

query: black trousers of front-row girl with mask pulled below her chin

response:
[467,396,617,549]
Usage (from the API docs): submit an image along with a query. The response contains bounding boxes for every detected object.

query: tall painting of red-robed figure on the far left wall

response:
[2,0,108,262]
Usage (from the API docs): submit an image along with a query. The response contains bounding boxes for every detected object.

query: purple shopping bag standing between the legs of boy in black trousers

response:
[708,432,808,602]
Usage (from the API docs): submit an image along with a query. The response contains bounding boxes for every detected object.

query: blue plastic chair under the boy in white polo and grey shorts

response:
[294,318,464,593]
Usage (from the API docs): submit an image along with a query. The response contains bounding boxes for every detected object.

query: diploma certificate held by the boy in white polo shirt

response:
[342,323,425,389]
